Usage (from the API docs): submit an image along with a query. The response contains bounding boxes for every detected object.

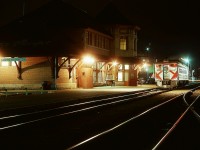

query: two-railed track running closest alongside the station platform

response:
[0,88,168,131]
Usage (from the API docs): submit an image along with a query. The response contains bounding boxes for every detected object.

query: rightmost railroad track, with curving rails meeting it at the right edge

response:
[152,87,200,150]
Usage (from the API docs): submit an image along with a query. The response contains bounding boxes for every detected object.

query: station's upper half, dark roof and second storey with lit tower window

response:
[0,1,139,62]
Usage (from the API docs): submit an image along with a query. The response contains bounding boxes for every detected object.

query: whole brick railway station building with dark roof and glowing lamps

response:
[0,0,141,89]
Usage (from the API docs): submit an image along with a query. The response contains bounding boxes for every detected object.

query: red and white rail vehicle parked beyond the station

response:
[154,61,189,88]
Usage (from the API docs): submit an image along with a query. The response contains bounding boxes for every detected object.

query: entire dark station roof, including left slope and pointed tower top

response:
[0,0,139,61]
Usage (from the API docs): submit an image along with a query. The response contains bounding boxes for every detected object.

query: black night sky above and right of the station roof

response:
[0,0,200,67]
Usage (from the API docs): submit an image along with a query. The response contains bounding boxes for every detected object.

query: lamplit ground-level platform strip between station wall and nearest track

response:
[0,84,156,111]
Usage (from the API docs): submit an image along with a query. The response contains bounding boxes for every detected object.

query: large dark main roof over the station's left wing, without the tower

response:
[0,0,93,56]
